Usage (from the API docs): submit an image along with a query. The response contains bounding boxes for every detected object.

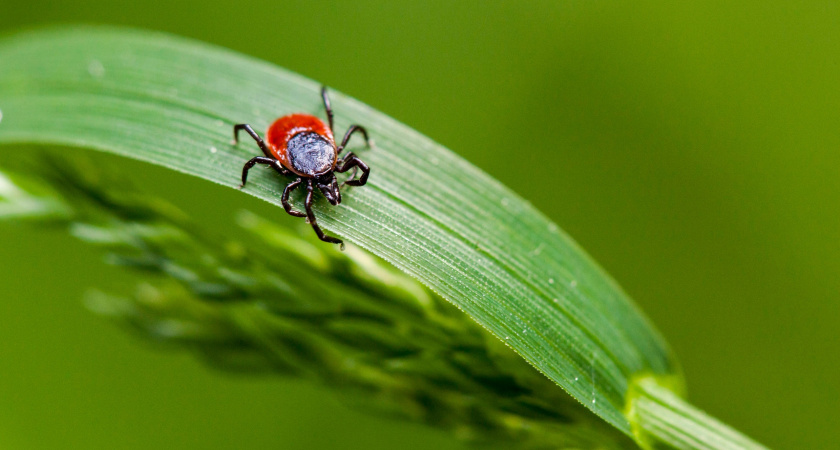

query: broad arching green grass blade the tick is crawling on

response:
[0,28,760,446]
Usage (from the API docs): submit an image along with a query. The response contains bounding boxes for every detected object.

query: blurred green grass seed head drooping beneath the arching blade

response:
[0,160,633,448]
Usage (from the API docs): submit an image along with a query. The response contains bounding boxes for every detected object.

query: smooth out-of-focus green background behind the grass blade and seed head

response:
[0,0,840,449]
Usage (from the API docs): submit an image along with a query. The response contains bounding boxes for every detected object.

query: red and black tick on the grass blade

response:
[233,86,370,245]
